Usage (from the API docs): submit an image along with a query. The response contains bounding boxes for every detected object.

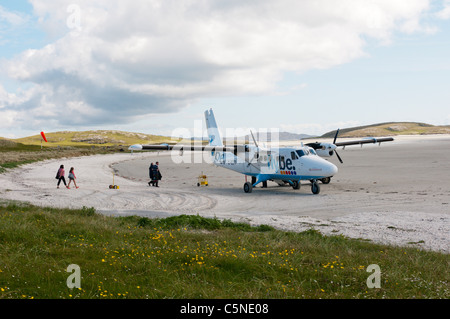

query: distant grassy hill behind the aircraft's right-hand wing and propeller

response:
[321,122,450,138]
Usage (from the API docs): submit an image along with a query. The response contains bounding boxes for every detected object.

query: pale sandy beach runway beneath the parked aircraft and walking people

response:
[0,135,450,253]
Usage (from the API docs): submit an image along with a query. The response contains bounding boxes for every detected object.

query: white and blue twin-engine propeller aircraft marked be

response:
[129,109,393,194]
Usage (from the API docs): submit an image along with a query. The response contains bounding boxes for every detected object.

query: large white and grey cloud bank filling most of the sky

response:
[3,0,440,132]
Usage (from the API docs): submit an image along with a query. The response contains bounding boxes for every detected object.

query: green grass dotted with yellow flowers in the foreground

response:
[0,204,450,299]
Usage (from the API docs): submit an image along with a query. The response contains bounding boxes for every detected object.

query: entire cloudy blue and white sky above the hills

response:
[0,0,450,137]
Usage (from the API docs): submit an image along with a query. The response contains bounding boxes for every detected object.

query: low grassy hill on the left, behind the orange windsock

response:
[11,130,180,147]
